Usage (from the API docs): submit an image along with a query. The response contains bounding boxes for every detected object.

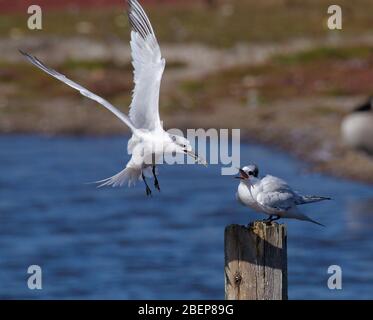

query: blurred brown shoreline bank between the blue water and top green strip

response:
[0,36,373,184]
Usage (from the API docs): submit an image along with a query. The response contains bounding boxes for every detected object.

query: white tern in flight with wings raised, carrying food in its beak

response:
[20,0,206,195]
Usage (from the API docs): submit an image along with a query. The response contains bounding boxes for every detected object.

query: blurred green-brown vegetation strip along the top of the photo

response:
[0,0,373,47]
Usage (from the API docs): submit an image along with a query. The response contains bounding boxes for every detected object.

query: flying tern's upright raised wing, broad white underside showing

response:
[128,0,166,130]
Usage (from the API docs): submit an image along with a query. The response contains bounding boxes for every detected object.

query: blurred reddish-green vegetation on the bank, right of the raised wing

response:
[174,46,373,105]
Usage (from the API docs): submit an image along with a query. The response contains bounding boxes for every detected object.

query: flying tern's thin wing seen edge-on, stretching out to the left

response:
[19,50,136,131]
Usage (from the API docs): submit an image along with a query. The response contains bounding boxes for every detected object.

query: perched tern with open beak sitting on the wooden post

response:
[236,164,330,226]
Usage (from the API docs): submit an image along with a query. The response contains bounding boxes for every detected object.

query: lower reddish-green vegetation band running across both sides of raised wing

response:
[0,40,373,111]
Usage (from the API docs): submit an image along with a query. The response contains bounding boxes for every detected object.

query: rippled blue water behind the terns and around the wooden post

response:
[0,136,373,299]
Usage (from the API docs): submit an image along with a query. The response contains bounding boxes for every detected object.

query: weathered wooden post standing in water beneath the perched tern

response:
[224,221,288,300]
